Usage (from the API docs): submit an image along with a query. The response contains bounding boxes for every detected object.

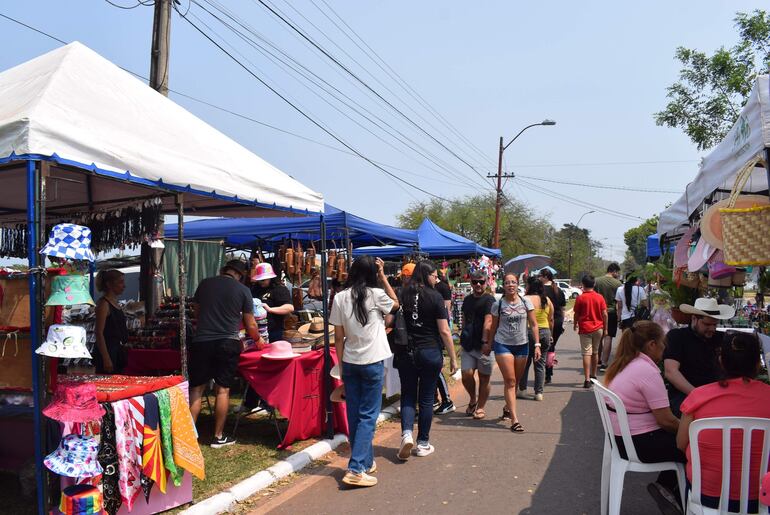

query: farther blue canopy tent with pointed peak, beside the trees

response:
[353,218,502,257]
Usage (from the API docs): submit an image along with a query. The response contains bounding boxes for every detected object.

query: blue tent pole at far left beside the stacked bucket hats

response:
[27,161,48,515]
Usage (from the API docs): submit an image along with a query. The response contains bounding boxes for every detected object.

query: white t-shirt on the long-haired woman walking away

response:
[329,288,393,365]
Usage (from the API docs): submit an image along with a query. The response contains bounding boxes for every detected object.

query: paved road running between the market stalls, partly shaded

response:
[252,329,658,515]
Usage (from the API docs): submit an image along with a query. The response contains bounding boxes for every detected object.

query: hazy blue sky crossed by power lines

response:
[0,0,766,259]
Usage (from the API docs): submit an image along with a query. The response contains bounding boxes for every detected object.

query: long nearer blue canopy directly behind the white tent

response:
[165,204,418,249]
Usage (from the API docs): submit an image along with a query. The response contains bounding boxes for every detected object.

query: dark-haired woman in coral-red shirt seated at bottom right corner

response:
[676,333,770,513]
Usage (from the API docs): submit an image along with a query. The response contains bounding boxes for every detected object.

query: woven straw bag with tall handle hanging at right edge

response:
[719,159,770,266]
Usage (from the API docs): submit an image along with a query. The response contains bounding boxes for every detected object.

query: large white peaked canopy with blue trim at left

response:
[0,42,323,216]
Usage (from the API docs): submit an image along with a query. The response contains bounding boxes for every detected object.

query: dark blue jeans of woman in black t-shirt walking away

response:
[394,344,444,444]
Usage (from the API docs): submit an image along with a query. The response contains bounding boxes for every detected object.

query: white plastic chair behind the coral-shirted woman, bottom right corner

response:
[687,418,770,515]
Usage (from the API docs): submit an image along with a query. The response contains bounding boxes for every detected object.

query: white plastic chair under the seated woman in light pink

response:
[591,379,686,515]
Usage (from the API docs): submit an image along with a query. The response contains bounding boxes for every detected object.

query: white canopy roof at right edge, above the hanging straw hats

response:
[658,75,770,236]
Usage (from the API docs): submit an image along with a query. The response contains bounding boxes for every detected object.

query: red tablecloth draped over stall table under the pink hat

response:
[238,347,348,449]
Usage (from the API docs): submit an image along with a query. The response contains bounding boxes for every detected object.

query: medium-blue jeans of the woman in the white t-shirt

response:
[342,361,385,474]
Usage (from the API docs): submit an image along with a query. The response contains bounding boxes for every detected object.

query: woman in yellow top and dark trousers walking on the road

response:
[518,276,554,401]
